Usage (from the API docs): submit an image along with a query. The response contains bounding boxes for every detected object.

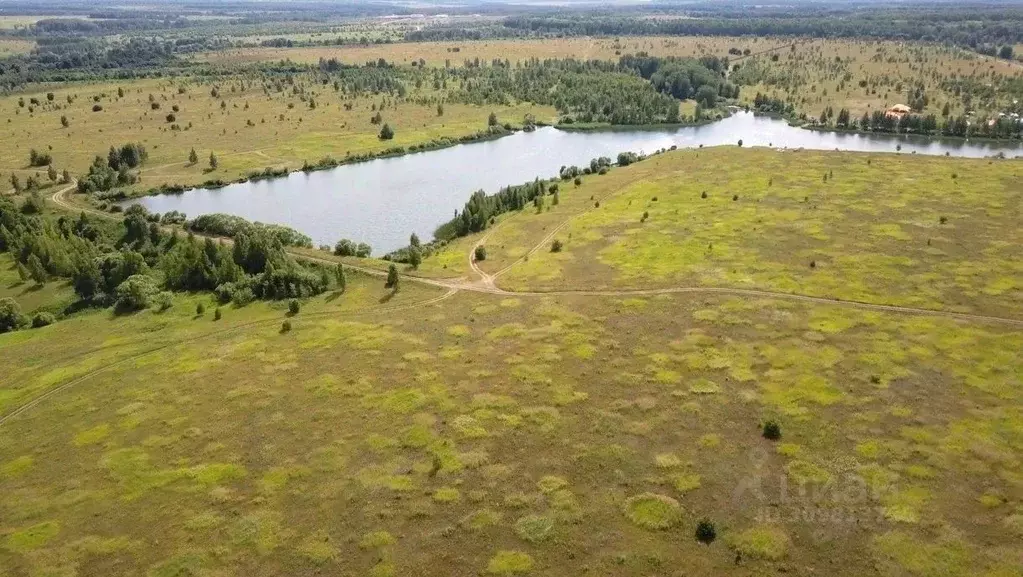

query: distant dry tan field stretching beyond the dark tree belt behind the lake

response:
[196,37,1023,119]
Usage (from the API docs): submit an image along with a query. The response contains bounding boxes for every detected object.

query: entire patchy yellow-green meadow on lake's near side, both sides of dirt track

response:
[0,147,1023,577]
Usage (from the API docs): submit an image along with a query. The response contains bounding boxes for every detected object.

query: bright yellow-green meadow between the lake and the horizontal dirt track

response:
[466,147,1023,316]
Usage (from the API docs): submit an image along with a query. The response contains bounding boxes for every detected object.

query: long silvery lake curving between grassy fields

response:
[125,113,1023,256]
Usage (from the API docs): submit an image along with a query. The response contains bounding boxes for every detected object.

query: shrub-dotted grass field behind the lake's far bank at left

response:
[0,78,555,188]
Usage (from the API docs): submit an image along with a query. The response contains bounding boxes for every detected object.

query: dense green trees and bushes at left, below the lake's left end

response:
[0,198,338,331]
